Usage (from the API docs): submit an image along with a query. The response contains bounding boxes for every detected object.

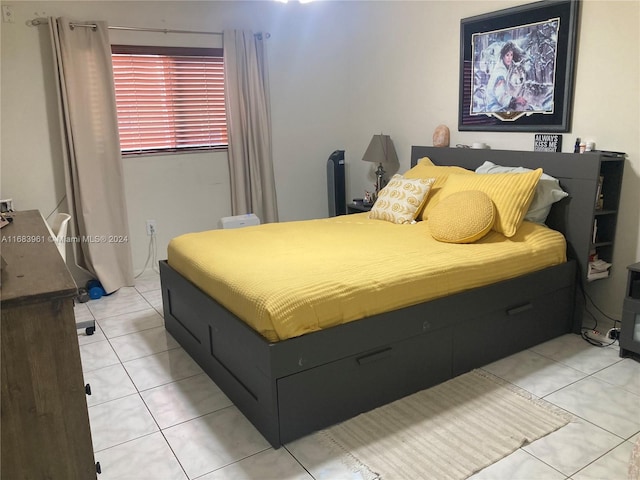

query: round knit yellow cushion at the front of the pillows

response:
[427,190,496,243]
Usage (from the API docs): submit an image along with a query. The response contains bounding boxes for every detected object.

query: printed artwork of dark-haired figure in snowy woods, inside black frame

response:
[470,18,560,121]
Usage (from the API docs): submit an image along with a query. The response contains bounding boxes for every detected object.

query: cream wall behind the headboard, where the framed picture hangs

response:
[338,0,640,318]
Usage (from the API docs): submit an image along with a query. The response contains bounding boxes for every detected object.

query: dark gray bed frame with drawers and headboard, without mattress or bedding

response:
[160,147,598,448]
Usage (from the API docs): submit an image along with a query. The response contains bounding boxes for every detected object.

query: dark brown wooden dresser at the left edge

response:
[0,210,97,480]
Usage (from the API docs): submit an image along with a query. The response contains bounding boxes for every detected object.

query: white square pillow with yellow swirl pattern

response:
[369,174,435,223]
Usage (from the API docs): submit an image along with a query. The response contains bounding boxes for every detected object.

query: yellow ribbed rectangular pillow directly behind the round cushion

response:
[440,168,542,237]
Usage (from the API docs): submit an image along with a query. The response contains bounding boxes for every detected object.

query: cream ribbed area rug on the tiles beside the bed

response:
[320,370,572,480]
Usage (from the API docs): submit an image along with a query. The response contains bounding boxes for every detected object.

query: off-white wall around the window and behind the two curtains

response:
[0,1,348,283]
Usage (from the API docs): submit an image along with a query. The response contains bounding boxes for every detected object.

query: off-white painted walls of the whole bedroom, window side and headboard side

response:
[1,0,640,315]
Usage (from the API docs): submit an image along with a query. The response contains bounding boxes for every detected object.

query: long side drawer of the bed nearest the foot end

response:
[278,329,451,443]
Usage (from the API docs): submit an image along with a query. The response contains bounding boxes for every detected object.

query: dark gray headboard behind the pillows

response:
[411,146,600,278]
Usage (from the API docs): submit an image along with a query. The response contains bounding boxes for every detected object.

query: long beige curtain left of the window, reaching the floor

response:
[49,18,134,293]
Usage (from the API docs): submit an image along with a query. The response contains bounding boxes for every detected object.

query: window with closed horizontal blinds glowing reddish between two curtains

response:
[111,45,227,154]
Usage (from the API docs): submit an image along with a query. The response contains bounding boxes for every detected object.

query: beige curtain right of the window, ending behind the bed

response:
[223,30,278,223]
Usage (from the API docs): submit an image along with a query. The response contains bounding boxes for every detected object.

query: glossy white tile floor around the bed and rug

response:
[76,273,640,480]
